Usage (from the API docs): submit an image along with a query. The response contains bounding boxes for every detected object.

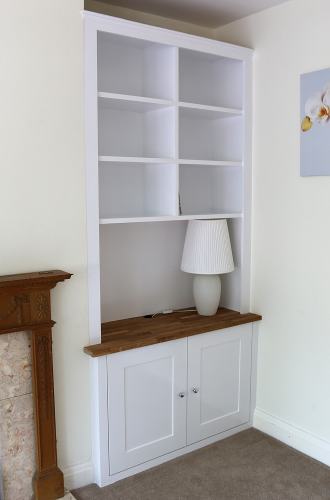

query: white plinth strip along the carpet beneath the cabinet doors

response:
[98,422,251,487]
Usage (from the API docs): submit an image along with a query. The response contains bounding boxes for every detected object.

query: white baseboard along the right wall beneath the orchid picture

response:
[253,408,330,466]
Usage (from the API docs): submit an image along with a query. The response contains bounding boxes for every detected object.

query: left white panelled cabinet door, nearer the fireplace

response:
[107,338,187,474]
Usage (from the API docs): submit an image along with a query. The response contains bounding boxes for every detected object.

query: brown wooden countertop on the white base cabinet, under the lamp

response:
[84,308,262,358]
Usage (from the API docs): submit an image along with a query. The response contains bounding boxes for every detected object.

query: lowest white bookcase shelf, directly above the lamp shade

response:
[100,213,242,225]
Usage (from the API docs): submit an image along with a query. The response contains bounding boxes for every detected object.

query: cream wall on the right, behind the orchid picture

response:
[218,0,330,456]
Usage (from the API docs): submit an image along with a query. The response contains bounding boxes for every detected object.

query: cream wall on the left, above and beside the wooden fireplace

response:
[0,0,91,486]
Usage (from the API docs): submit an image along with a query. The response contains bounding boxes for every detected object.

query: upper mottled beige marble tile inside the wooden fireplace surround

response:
[0,332,32,400]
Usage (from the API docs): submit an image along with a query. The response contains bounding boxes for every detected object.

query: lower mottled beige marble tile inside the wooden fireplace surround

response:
[0,394,35,500]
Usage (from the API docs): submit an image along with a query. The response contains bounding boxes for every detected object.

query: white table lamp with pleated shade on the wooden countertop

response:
[181,219,234,316]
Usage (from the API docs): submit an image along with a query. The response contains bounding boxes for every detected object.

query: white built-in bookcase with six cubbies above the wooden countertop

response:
[85,13,252,342]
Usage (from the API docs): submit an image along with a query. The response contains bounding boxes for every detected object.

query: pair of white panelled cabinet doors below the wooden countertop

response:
[107,324,252,475]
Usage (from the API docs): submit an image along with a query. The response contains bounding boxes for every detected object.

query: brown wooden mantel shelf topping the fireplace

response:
[0,270,72,288]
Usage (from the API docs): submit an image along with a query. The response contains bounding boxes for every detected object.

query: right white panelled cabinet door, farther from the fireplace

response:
[187,324,252,444]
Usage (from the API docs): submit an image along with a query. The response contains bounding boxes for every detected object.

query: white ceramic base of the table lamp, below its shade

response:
[193,274,221,316]
